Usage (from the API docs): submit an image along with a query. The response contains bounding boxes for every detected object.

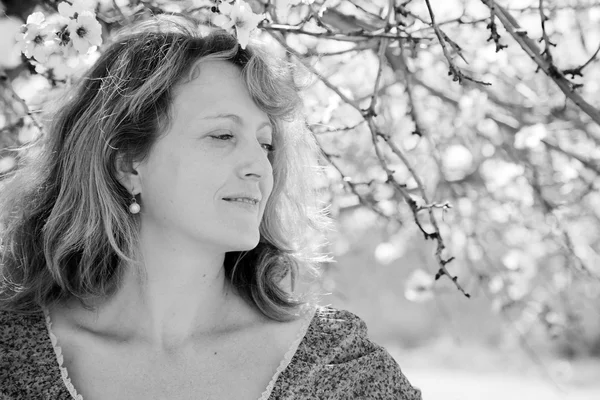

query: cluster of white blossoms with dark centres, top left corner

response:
[16,0,102,64]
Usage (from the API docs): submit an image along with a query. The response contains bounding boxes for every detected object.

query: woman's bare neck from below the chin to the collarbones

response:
[63,255,264,350]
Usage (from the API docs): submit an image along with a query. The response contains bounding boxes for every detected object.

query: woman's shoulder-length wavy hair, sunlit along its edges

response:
[0,16,333,321]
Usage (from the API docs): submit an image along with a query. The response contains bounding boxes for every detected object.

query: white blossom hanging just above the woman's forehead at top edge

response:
[213,0,264,49]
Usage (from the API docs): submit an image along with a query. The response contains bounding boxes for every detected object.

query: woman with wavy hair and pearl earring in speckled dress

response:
[0,17,420,400]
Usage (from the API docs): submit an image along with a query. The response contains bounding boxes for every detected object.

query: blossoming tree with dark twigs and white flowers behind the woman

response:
[0,0,600,362]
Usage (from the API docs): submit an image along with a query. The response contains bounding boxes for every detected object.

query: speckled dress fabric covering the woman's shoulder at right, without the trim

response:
[284,307,422,400]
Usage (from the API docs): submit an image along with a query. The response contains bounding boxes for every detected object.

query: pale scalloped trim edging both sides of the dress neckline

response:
[42,304,318,400]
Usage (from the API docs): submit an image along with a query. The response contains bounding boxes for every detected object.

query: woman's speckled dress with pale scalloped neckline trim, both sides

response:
[0,306,421,400]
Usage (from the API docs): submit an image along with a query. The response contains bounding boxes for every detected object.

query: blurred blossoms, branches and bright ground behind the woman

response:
[0,0,600,400]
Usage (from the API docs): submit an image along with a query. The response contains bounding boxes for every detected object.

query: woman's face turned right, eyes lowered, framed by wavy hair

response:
[138,61,273,252]
